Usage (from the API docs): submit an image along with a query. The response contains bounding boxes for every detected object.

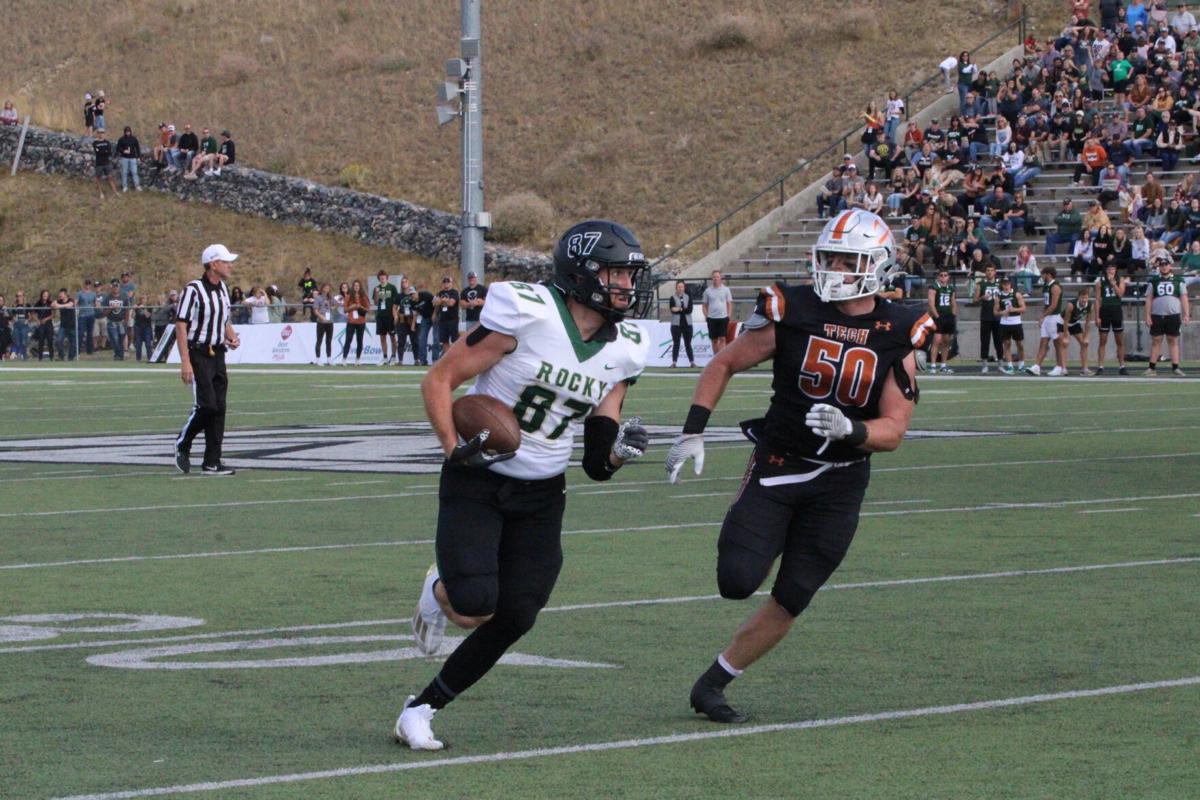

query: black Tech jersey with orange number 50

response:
[746,283,934,462]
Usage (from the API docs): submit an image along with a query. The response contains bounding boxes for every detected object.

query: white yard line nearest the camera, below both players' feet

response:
[51,675,1200,800]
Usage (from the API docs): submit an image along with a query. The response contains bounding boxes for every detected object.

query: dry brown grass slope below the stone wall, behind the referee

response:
[0,172,445,297]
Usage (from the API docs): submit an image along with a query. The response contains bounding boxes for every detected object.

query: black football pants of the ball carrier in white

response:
[437,464,566,616]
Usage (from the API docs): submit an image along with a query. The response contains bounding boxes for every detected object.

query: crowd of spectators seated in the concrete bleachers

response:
[817,0,1200,298]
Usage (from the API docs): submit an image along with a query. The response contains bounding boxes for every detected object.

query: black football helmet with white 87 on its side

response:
[554,219,646,323]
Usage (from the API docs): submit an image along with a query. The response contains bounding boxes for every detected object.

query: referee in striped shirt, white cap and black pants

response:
[175,245,240,475]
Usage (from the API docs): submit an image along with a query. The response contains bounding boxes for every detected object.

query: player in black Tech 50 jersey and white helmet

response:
[666,210,934,722]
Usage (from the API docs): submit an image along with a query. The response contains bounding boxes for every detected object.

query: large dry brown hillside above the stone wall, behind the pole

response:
[0,0,1022,253]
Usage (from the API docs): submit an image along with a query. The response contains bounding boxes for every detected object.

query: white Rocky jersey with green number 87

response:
[468,283,649,480]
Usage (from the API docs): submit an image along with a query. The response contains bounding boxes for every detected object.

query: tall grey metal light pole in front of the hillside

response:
[437,0,492,287]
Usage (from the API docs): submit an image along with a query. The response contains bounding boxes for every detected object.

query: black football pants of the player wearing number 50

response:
[716,457,871,614]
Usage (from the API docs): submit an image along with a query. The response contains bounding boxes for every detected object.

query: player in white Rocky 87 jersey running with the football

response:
[395,219,649,750]
